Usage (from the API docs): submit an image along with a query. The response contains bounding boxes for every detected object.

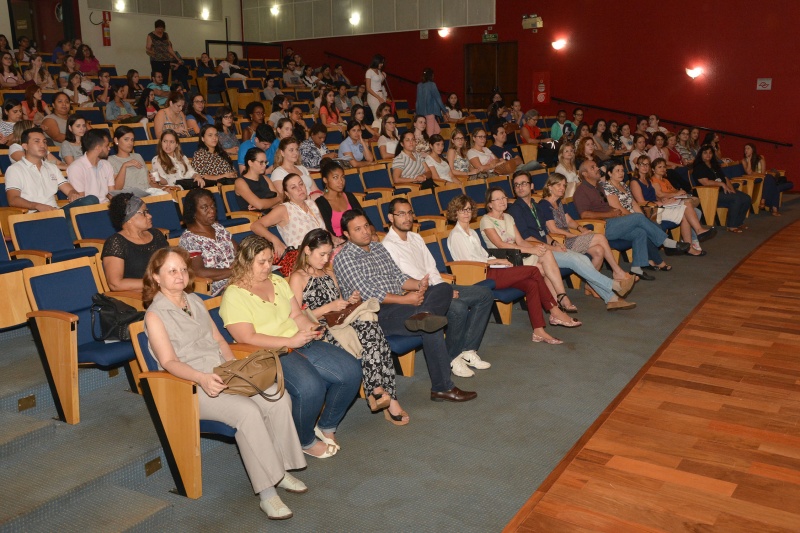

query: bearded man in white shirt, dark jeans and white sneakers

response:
[382,198,494,377]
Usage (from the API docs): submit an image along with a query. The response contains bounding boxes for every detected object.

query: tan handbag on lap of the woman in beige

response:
[214,348,288,402]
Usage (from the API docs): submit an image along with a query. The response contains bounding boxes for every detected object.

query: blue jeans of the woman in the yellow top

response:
[281,341,361,449]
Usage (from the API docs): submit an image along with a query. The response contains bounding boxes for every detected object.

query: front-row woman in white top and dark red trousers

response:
[447,189,581,344]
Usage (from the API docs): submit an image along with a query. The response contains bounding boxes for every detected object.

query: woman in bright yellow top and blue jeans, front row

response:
[220,235,362,459]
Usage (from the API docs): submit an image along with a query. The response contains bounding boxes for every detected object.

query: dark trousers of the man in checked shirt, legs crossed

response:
[376,283,455,390]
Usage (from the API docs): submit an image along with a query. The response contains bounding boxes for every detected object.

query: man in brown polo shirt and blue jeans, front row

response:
[572,160,691,279]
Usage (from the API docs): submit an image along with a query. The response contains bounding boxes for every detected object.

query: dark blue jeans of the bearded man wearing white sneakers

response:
[445,285,494,361]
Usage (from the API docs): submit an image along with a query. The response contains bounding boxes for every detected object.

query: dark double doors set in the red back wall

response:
[464,42,517,109]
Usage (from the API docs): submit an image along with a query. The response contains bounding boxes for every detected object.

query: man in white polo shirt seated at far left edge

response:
[6,127,98,238]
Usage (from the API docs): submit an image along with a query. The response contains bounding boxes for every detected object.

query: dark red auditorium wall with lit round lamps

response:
[287,0,800,188]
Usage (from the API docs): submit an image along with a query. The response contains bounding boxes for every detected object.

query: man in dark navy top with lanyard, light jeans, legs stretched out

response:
[507,171,636,311]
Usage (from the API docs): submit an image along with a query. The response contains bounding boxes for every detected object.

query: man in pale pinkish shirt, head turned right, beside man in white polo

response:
[67,129,116,204]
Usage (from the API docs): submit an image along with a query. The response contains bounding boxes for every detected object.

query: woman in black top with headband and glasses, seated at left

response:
[101,193,169,291]
